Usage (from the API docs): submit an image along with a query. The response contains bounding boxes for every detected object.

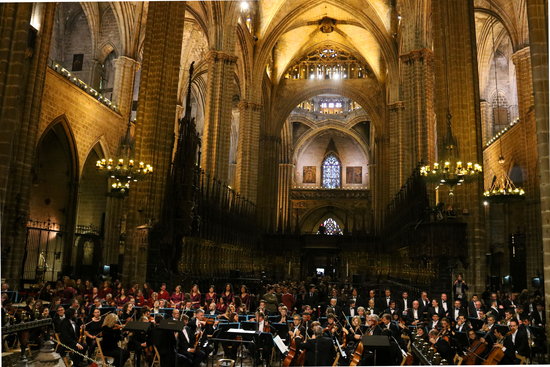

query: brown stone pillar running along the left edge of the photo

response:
[0,3,55,287]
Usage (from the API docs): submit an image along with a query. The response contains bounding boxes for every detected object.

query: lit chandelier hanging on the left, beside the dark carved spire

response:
[96,122,153,196]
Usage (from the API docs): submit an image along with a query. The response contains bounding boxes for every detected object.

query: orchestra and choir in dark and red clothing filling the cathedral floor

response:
[2,280,546,366]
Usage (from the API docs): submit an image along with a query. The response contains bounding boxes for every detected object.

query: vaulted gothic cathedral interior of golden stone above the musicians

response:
[0,0,550,366]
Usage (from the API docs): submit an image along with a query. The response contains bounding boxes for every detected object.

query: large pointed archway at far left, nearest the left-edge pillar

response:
[22,120,78,281]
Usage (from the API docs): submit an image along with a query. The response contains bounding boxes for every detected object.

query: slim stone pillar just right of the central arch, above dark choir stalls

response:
[388,101,410,200]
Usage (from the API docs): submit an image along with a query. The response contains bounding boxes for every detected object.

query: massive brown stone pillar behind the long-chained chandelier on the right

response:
[432,0,488,293]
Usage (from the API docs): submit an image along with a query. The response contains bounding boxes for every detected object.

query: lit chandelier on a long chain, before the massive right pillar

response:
[420,2,482,206]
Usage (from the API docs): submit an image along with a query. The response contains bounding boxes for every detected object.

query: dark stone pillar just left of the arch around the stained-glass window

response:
[257,134,281,232]
